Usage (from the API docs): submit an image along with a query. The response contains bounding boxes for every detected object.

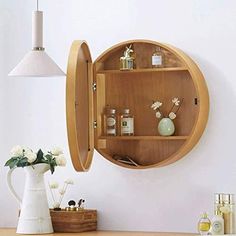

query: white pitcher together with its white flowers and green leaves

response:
[5,145,66,234]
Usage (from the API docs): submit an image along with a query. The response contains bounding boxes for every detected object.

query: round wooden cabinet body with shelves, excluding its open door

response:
[94,40,209,168]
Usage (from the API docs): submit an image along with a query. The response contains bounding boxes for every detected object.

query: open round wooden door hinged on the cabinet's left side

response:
[66,41,94,171]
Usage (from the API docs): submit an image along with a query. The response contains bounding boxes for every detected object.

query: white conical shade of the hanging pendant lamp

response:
[8,50,65,77]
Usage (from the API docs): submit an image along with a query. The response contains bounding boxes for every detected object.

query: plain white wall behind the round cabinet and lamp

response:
[0,0,236,232]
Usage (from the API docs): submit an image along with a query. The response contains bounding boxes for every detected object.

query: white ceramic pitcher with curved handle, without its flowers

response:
[7,163,53,234]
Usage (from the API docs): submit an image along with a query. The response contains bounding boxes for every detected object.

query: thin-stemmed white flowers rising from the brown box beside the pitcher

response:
[48,179,74,211]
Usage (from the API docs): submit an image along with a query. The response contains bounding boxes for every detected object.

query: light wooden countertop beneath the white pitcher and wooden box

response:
[0,228,196,236]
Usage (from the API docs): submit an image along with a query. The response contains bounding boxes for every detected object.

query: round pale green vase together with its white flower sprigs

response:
[151,98,183,136]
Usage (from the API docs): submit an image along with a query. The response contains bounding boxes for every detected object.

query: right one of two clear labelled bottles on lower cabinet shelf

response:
[120,109,134,136]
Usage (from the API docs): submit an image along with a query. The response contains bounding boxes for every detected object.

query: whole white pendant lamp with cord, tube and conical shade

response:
[8,0,65,77]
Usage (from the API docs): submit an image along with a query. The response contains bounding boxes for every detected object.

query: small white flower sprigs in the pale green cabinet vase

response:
[151,97,183,120]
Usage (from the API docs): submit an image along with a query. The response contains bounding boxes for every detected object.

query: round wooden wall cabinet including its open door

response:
[66,40,209,171]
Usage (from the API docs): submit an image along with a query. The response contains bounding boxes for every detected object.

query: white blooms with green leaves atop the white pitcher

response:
[5,145,66,174]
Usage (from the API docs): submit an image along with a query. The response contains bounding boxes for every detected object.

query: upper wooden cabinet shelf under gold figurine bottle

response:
[97,67,188,74]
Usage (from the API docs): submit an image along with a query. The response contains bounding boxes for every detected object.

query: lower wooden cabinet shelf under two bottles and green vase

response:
[99,136,188,140]
